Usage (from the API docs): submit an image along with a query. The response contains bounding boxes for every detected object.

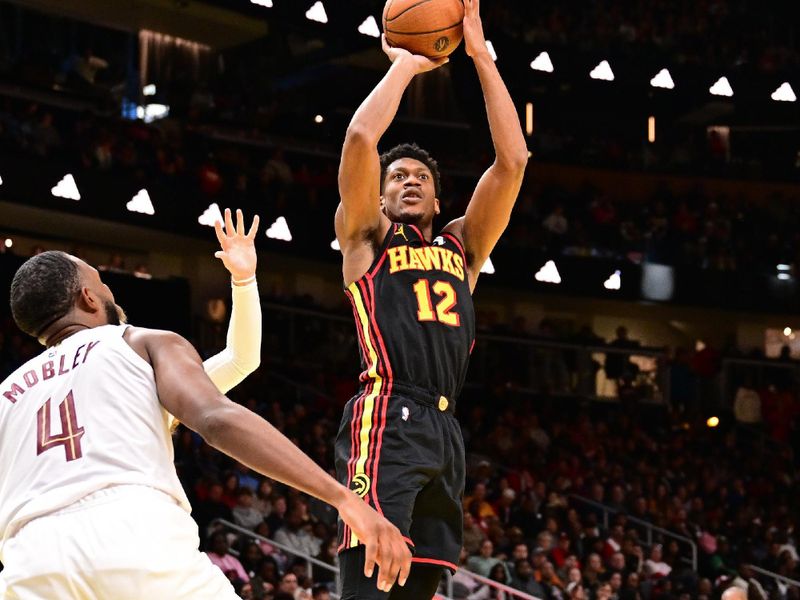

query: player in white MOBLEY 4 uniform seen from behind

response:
[0,210,411,600]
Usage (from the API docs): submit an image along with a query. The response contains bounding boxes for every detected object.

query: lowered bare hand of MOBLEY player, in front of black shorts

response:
[339,492,411,592]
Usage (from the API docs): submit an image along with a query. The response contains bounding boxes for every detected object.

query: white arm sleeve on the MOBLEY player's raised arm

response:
[203,282,261,394]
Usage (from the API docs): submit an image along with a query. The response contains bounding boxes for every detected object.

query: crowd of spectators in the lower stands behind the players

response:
[0,261,800,600]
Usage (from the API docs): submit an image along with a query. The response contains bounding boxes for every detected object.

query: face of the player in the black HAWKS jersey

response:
[381,158,439,226]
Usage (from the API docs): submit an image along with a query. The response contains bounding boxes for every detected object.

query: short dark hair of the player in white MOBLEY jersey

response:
[10,250,81,337]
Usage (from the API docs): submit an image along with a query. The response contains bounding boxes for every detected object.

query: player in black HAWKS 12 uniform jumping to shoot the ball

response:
[335,0,528,600]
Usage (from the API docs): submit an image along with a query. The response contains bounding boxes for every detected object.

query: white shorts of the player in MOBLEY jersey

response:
[0,485,238,600]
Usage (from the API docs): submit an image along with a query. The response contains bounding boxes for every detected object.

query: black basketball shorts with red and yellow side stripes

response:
[335,382,465,571]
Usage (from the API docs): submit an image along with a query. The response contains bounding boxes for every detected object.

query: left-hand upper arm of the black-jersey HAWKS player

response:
[336,130,382,241]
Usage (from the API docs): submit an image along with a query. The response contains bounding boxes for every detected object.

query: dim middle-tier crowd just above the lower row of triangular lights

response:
[0,96,800,273]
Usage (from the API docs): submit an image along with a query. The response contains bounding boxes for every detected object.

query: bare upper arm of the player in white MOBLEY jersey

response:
[146,332,228,434]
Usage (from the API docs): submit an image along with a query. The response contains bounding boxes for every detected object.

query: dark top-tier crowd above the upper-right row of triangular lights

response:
[485,0,800,72]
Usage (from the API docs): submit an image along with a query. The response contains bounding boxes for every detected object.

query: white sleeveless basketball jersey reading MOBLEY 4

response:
[0,325,191,560]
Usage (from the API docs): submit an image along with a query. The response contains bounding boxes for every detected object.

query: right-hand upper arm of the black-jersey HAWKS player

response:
[463,165,525,269]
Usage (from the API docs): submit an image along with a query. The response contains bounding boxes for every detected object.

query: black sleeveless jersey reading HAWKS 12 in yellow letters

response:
[346,223,475,410]
